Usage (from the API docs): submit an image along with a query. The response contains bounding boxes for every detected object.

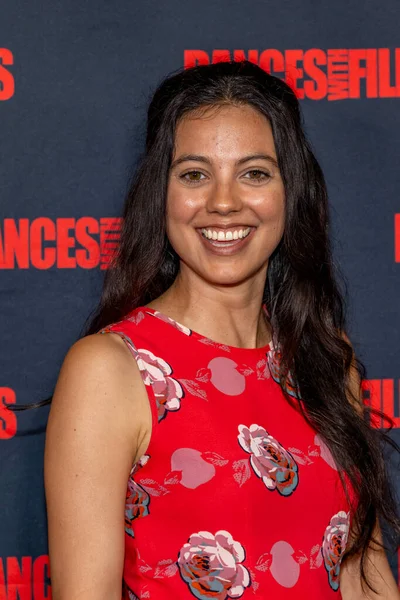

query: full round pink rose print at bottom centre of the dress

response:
[178,530,250,600]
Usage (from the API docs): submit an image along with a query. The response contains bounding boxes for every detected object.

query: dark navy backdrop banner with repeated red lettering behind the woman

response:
[0,0,400,600]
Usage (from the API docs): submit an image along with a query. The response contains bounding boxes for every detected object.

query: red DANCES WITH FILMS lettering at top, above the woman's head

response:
[183,48,400,100]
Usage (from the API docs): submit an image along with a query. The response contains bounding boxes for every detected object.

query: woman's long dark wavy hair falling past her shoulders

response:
[7,61,400,589]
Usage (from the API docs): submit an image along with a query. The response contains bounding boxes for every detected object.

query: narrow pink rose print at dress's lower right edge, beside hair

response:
[321,510,350,591]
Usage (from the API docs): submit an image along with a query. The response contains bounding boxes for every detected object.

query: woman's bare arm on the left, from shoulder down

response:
[45,334,151,600]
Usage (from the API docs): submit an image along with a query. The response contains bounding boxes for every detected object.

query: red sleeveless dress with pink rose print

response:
[98,306,352,600]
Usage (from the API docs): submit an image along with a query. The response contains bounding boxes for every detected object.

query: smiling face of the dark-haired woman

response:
[167,105,285,285]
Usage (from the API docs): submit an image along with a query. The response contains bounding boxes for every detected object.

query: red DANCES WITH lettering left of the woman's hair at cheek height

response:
[0,217,122,269]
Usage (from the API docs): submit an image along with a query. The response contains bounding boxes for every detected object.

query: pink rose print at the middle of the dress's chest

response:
[238,424,299,496]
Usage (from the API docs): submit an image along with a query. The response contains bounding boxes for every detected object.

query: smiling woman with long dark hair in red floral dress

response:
[45,62,399,600]
